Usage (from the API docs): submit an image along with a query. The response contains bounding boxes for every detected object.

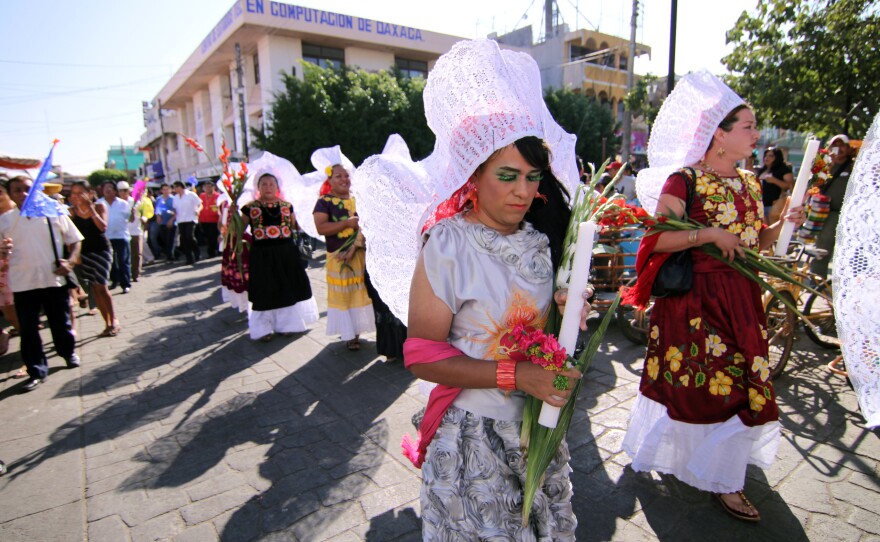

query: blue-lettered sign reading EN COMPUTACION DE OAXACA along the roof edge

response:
[246,0,425,42]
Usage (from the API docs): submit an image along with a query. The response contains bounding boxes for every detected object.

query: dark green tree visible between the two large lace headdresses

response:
[544,89,620,166]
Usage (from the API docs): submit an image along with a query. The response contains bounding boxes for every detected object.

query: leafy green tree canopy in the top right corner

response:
[722,0,880,137]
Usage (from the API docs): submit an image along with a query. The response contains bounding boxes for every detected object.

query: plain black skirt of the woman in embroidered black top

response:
[248,239,312,311]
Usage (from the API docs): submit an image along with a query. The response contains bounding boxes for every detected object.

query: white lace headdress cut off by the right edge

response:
[833,114,880,427]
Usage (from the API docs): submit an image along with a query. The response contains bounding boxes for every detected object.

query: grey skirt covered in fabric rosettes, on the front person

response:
[421,407,577,542]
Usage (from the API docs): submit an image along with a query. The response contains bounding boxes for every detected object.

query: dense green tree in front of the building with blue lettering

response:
[252,63,434,172]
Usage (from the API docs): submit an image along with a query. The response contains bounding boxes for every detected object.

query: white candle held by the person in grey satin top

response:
[538,222,596,429]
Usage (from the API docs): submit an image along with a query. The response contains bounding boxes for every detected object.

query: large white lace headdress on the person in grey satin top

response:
[352,40,578,323]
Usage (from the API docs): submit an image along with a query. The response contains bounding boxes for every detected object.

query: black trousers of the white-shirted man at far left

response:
[12,286,76,379]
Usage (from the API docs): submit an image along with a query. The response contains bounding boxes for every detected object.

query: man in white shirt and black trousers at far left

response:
[0,177,83,391]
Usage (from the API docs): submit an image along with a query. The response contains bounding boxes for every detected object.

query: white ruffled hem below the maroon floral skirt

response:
[623,393,780,493]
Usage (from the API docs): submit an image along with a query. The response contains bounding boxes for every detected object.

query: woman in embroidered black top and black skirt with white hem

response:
[235,173,318,342]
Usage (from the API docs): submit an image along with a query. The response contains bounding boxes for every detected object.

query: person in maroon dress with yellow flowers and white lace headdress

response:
[623,72,803,521]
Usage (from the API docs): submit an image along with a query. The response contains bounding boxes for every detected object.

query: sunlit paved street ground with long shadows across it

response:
[0,253,880,542]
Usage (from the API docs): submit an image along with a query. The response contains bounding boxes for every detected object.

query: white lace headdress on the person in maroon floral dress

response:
[636,70,745,214]
